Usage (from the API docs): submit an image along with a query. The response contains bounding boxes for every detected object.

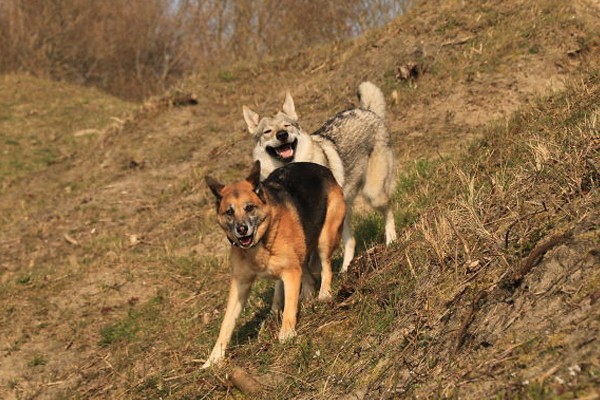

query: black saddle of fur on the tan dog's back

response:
[263,162,339,247]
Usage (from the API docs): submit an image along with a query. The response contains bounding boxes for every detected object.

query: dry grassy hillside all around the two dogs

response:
[0,0,600,399]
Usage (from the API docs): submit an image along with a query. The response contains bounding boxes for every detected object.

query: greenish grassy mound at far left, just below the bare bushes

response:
[0,75,133,187]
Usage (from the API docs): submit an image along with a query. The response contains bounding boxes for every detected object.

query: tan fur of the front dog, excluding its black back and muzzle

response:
[203,163,345,368]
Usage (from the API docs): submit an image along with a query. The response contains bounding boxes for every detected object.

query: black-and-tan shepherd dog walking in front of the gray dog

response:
[203,161,346,368]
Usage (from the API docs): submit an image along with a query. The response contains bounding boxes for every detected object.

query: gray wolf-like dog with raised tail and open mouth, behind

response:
[243,82,396,272]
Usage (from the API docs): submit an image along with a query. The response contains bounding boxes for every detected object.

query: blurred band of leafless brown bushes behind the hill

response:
[0,0,410,99]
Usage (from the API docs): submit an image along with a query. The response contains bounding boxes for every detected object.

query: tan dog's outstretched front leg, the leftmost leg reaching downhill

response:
[202,266,254,368]
